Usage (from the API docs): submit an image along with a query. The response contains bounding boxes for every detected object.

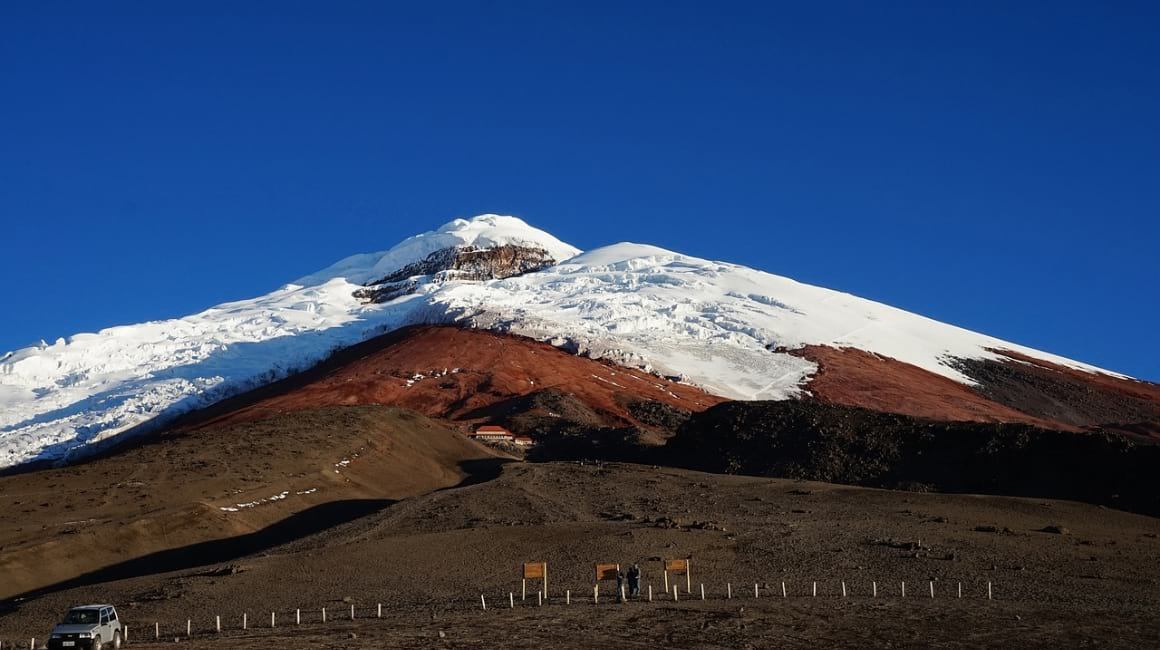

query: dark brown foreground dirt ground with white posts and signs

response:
[0,463,1160,648]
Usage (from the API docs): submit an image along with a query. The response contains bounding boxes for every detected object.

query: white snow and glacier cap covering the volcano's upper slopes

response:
[0,215,1136,467]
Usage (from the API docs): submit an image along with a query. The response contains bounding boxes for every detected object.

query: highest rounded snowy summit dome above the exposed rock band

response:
[293,215,580,287]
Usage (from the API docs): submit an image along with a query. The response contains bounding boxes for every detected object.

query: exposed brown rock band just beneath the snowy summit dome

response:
[355,244,558,303]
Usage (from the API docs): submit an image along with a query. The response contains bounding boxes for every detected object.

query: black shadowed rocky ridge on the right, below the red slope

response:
[665,400,1160,515]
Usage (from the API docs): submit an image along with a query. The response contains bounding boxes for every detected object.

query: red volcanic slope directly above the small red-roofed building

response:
[179,326,724,428]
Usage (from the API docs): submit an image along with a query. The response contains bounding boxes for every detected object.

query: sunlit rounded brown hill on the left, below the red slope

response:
[0,406,508,598]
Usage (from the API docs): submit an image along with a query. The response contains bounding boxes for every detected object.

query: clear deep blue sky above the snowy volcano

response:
[0,1,1160,381]
